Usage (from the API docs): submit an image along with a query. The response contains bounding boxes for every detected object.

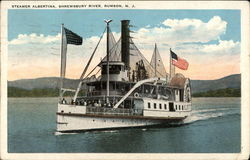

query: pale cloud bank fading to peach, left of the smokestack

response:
[8,32,120,80]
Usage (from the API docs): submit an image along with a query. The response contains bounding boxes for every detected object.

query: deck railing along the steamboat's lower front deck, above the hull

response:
[86,107,142,116]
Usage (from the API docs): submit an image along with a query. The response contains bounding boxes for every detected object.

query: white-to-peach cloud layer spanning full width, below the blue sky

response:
[8,16,240,80]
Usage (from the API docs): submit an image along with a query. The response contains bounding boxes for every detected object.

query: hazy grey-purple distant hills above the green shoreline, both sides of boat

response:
[8,74,241,93]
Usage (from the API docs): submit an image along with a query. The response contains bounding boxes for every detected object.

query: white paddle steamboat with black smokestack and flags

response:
[56,20,191,133]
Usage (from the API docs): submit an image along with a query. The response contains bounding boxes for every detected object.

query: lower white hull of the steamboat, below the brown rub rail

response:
[57,115,182,132]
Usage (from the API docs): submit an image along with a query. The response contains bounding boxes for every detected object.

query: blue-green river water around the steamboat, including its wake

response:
[8,98,241,153]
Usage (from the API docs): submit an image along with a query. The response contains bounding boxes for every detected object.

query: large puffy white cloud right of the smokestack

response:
[136,16,227,46]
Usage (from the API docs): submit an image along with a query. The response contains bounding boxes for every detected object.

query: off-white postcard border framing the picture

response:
[0,1,250,160]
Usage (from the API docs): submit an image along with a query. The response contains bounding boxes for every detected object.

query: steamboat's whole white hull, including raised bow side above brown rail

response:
[57,104,190,132]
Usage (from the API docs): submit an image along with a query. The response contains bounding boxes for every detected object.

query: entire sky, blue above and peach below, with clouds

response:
[8,9,241,80]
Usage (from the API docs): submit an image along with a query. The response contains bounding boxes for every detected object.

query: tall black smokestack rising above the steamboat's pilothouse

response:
[121,20,130,69]
